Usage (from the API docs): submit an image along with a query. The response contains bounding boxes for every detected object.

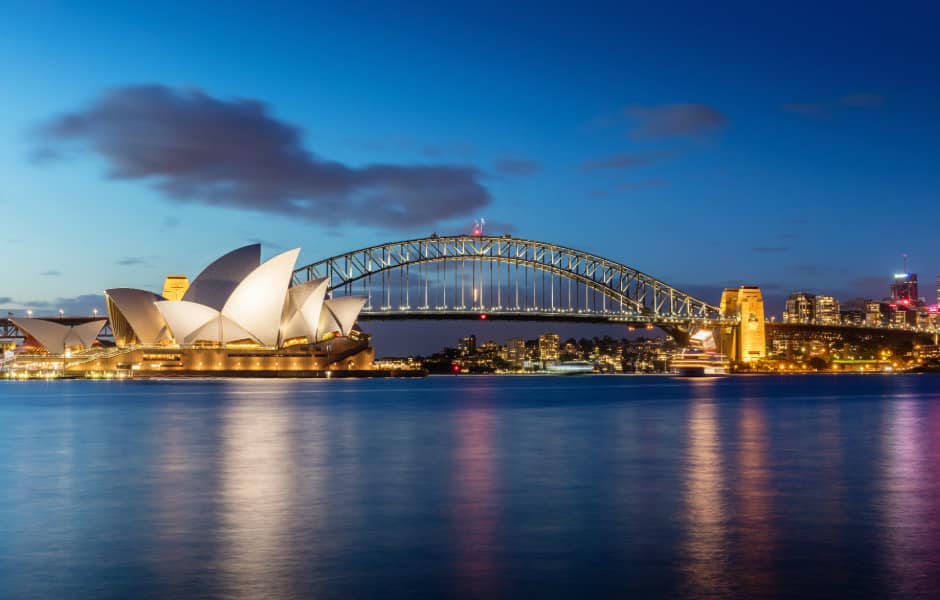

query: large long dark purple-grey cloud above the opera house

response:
[36,85,490,228]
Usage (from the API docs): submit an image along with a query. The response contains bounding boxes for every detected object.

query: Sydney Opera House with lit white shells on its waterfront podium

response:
[13,244,374,376]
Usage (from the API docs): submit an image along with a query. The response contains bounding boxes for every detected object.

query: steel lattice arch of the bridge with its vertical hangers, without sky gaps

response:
[294,235,722,324]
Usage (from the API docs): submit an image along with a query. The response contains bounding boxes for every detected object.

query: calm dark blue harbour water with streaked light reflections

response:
[0,375,940,598]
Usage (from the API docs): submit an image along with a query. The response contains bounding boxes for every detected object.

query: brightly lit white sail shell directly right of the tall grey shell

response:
[222,248,300,346]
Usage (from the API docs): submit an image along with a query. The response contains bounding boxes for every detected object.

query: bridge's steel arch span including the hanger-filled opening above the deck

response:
[294,235,719,323]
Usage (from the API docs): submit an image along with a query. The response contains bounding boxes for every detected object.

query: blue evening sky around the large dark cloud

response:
[0,0,940,352]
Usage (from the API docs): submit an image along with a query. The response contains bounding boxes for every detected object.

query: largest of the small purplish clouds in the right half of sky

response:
[625,103,728,139]
